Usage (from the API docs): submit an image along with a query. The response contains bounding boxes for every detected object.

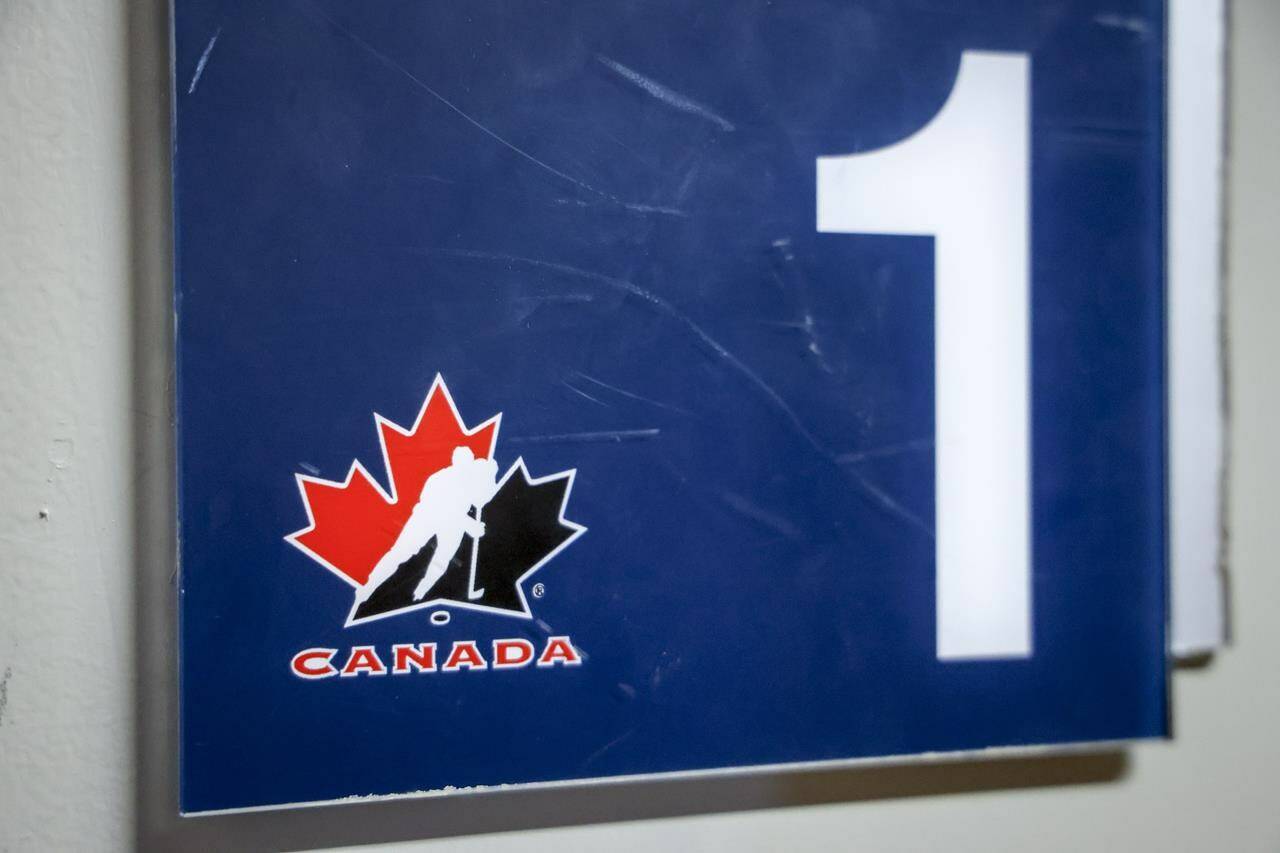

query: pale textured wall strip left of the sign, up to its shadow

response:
[0,0,133,850]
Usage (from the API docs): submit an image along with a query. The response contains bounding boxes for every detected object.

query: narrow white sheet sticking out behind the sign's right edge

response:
[1167,0,1226,657]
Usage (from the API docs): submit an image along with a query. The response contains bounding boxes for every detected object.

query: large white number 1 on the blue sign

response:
[818,51,1032,660]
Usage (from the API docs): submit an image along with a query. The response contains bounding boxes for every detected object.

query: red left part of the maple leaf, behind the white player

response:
[284,375,502,587]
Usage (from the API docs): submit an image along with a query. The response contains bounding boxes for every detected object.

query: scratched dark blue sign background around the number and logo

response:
[174,0,1166,812]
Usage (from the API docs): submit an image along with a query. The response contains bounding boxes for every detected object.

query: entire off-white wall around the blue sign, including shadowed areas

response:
[0,0,1280,852]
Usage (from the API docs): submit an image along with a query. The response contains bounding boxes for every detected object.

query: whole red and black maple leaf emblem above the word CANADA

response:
[285,377,586,626]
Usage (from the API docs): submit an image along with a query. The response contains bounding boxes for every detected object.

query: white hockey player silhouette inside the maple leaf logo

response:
[356,447,498,603]
